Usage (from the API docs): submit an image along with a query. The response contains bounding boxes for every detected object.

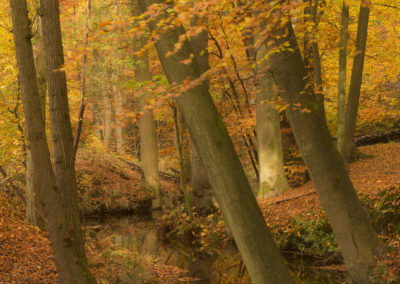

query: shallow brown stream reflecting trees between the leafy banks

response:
[85,215,346,284]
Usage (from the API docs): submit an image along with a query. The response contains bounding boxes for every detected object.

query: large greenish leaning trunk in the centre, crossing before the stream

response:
[139,0,294,284]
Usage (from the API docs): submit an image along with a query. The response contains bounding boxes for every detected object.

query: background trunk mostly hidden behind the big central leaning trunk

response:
[190,20,213,216]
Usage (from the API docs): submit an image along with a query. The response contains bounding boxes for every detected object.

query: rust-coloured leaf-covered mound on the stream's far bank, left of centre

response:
[76,142,178,215]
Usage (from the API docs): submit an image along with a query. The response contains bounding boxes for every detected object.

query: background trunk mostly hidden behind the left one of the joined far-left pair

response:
[25,14,47,230]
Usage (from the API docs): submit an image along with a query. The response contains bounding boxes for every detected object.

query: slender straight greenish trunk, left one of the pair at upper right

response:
[337,0,349,162]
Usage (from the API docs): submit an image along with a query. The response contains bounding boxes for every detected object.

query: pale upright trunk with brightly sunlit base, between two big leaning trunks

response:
[256,33,289,197]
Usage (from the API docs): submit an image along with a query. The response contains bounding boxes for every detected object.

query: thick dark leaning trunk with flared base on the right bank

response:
[268,14,382,283]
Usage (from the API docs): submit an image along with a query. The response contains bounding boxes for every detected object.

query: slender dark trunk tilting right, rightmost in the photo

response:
[344,0,370,161]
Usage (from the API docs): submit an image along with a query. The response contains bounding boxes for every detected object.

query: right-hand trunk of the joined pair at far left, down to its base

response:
[41,0,96,283]
